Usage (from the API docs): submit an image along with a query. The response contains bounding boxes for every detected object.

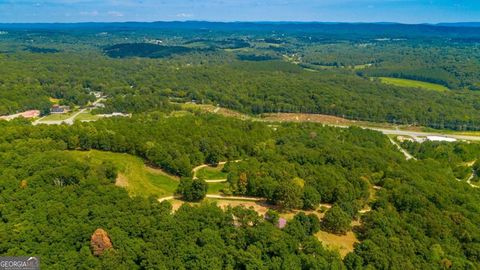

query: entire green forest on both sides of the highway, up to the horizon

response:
[0,22,480,270]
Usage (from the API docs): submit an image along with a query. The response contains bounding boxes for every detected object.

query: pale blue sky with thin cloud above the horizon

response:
[0,0,480,23]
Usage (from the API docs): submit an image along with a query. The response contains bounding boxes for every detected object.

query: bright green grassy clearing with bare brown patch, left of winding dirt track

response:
[66,150,178,197]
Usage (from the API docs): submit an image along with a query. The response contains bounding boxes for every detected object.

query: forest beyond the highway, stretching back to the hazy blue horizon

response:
[0,23,480,130]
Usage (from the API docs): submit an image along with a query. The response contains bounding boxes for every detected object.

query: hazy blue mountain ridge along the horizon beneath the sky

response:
[0,21,480,38]
